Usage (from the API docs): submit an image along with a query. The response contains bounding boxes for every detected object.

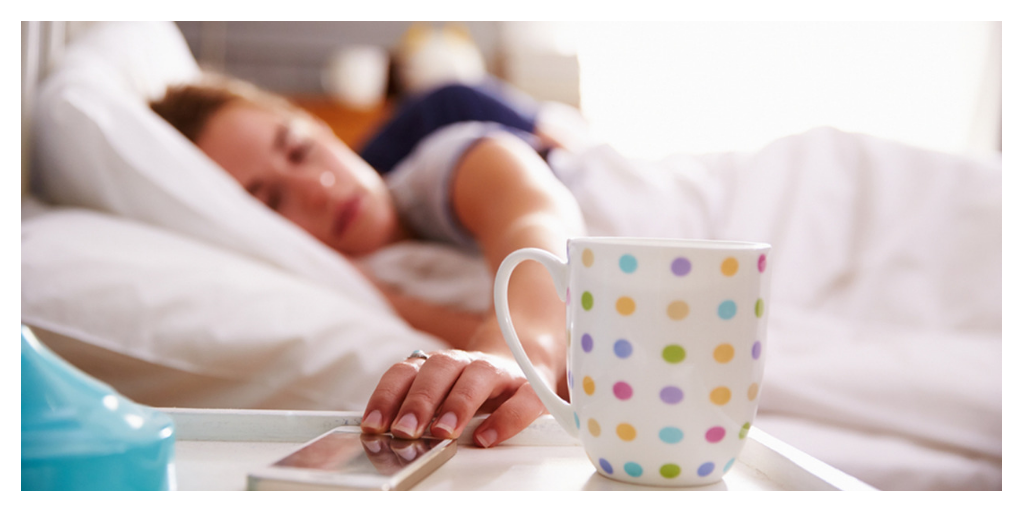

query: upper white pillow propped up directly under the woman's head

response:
[33,23,387,307]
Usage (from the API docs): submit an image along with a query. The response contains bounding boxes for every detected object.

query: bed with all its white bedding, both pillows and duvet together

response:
[22,23,1002,489]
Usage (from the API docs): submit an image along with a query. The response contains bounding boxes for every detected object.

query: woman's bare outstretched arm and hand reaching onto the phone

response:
[364,136,584,446]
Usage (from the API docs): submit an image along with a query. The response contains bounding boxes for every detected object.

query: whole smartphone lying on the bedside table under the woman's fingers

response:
[248,427,457,490]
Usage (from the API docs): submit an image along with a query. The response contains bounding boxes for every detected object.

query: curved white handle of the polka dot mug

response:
[495,248,579,436]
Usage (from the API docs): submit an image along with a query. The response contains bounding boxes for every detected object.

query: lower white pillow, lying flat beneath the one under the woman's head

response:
[22,200,442,411]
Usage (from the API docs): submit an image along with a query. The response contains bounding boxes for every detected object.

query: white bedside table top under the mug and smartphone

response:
[162,409,874,490]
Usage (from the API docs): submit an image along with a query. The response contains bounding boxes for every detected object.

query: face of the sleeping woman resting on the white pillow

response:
[197,101,400,256]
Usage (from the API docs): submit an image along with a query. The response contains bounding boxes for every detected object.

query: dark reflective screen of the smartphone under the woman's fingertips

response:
[273,431,441,476]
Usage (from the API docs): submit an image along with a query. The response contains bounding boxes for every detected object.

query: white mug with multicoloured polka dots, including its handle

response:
[495,238,771,486]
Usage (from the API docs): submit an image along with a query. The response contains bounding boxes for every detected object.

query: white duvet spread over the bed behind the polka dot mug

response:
[368,128,1002,489]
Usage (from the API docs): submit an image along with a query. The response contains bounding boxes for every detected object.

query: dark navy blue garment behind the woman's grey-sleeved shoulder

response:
[359,81,537,174]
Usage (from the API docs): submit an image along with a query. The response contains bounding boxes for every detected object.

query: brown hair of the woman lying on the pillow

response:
[150,75,308,143]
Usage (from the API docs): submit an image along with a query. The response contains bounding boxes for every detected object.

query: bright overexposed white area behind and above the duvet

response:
[577,22,1001,158]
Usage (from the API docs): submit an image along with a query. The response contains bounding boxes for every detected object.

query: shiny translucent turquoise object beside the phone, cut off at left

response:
[22,326,174,490]
